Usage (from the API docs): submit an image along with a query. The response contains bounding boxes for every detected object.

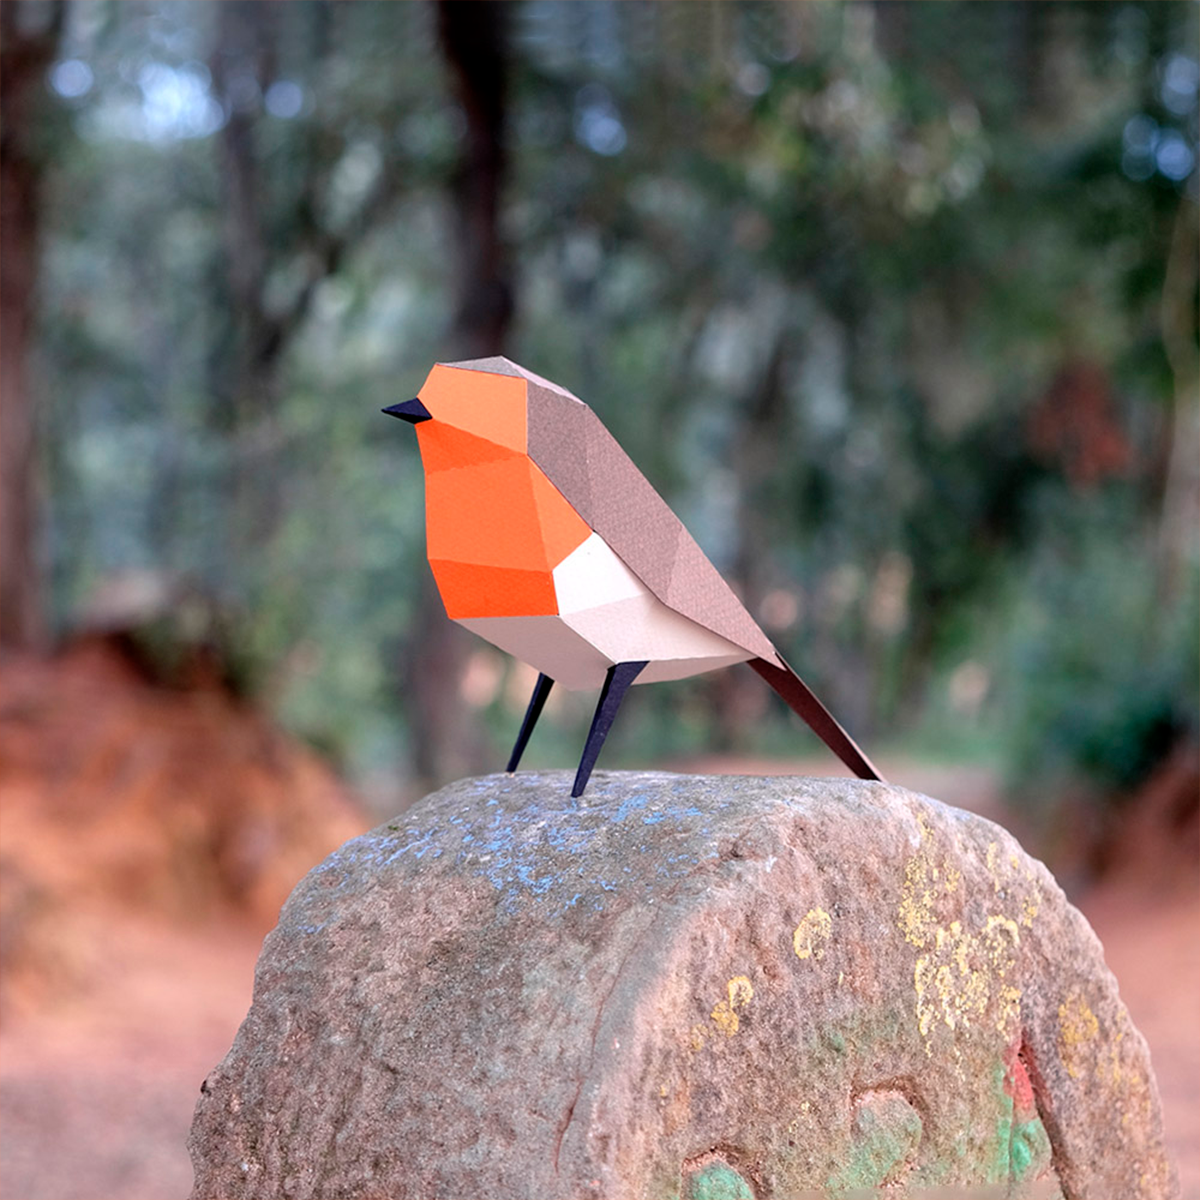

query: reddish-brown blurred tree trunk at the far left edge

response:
[0,0,62,650]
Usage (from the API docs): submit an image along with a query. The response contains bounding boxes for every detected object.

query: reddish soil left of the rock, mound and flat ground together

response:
[0,640,366,1200]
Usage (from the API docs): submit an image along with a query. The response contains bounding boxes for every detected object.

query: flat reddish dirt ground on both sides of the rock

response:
[0,768,1200,1200]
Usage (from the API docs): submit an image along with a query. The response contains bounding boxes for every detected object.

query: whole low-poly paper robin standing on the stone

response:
[384,358,881,797]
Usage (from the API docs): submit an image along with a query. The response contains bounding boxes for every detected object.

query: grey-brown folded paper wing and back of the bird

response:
[517,368,780,664]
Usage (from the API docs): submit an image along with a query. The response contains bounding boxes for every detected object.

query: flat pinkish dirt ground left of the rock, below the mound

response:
[0,914,260,1200]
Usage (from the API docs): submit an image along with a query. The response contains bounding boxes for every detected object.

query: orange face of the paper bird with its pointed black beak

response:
[384,360,527,472]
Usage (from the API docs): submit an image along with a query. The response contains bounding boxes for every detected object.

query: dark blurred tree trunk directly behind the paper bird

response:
[402,0,515,787]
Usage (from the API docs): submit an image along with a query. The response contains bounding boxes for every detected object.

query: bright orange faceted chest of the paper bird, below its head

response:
[425,454,592,617]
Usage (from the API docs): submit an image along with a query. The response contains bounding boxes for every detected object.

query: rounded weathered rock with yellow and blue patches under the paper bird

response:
[191,773,1177,1200]
